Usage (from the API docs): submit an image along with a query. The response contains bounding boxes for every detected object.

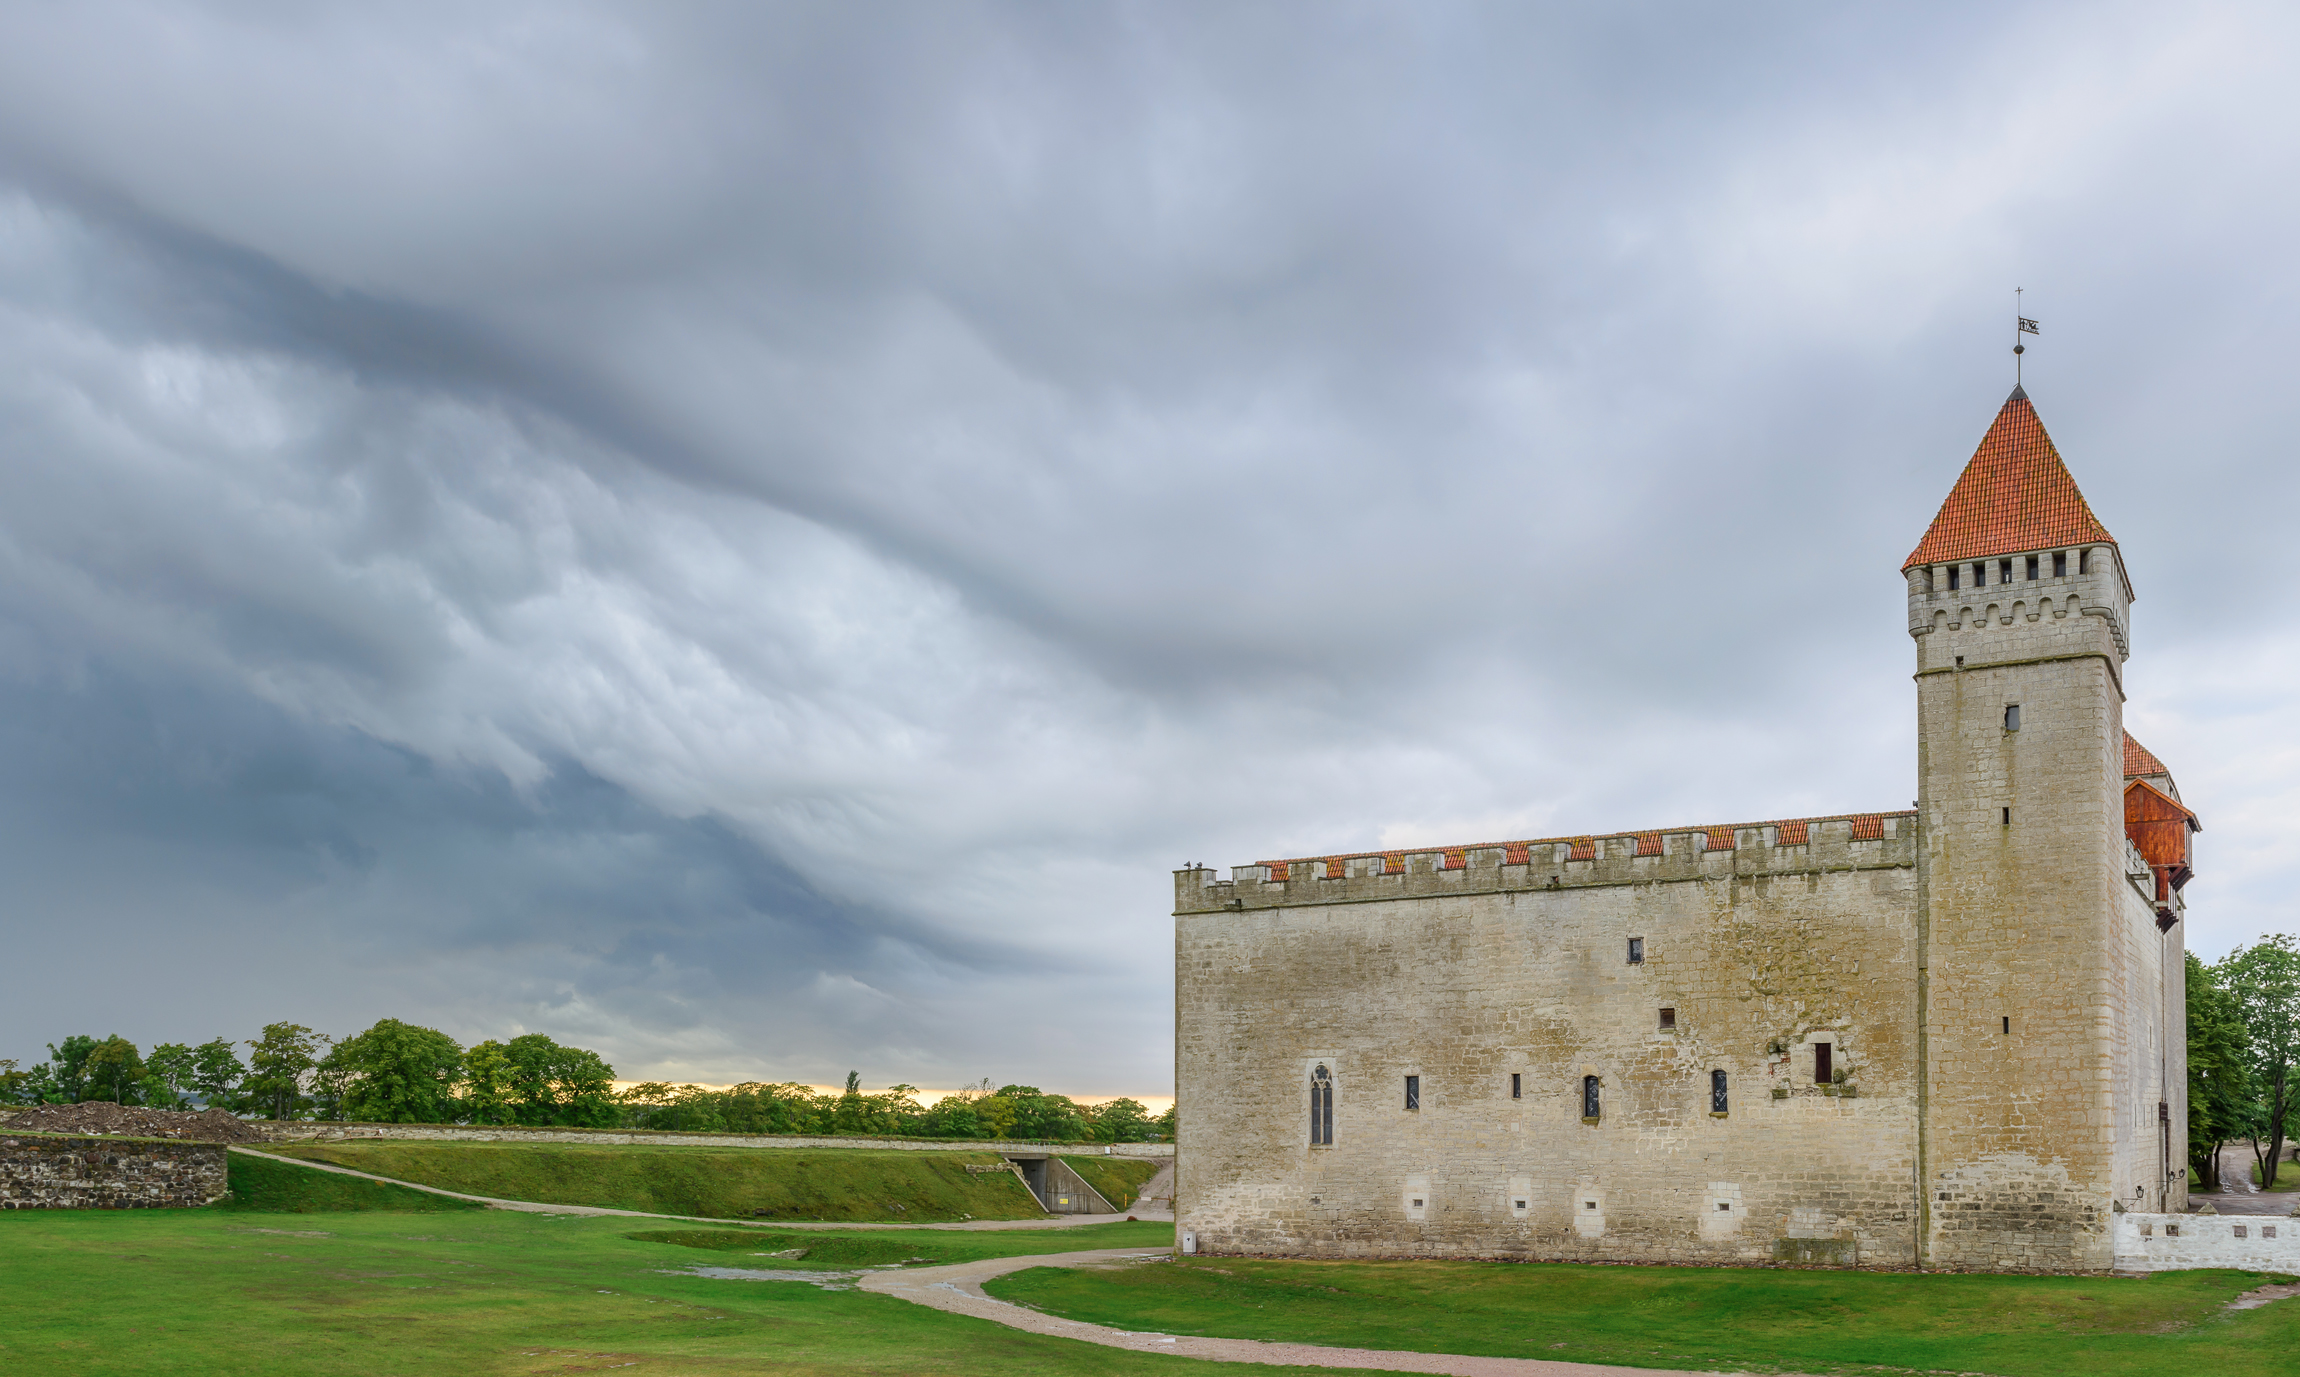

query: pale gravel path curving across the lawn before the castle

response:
[860,1248,1794,1377]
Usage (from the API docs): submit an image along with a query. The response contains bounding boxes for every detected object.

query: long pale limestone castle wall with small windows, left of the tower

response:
[1175,814,1918,1267]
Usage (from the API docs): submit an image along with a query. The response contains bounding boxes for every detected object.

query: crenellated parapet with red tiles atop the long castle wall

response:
[1173,811,1918,915]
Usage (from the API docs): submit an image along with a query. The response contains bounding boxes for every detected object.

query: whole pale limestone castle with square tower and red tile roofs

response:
[1175,389,2201,1271]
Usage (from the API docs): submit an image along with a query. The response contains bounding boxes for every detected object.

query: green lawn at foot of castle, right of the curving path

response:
[984,1257,2300,1377]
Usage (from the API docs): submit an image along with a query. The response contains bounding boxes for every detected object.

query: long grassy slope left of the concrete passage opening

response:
[276,1140,1044,1223]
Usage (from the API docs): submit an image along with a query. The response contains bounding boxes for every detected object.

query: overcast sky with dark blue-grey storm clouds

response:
[0,0,2300,1094]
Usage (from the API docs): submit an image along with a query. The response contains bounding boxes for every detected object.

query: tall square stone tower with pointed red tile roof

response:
[1902,389,2178,1269]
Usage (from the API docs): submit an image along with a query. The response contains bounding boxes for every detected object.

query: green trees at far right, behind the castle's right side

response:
[2187,933,2300,1191]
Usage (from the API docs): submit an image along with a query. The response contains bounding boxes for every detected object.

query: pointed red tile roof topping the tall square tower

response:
[1900,389,2116,570]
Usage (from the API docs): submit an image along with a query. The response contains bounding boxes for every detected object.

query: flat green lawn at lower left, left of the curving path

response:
[0,1204,1223,1377]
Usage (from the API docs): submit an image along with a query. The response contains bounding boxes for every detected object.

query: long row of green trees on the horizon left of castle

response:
[0,1018,1173,1143]
